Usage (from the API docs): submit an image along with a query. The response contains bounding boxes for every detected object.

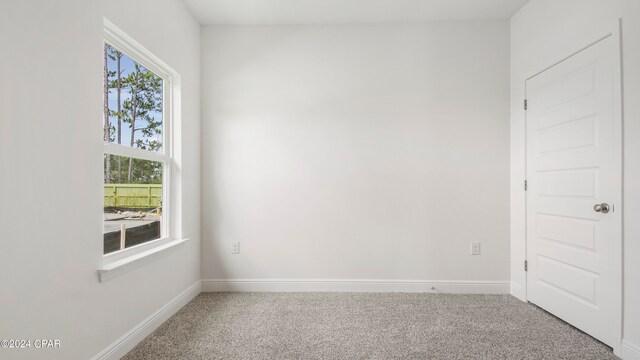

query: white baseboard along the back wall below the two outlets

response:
[202,279,509,294]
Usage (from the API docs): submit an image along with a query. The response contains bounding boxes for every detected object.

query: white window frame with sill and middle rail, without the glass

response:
[98,19,188,281]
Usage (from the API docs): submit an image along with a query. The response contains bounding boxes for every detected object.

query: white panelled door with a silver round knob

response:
[526,35,622,346]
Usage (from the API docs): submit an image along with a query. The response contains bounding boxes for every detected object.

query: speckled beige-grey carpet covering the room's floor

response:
[124,293,617,360]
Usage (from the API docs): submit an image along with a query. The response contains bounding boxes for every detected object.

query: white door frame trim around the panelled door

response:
[522,19,624,355]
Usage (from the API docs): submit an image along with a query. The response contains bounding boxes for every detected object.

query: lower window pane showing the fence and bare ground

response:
[103,154,163,254]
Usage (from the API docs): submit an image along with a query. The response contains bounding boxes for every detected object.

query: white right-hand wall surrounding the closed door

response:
[511,0,640,359]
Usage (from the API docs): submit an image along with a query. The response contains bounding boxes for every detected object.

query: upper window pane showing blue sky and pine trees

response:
[103,44,163,152]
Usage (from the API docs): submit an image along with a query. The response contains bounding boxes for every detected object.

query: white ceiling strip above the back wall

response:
[183,0,529,25]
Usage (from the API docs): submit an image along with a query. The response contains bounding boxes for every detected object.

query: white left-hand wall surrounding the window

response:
[0,0,200,359]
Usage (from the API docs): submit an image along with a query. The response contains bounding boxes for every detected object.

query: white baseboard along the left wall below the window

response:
[92,281,202,360]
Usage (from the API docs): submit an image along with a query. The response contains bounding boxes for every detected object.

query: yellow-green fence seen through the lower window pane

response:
[104,184,162,209]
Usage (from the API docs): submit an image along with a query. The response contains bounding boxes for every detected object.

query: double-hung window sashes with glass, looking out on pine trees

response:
[103,28,173,255]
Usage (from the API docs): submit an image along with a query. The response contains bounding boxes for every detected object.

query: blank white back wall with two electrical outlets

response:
[202,21,509,281]
